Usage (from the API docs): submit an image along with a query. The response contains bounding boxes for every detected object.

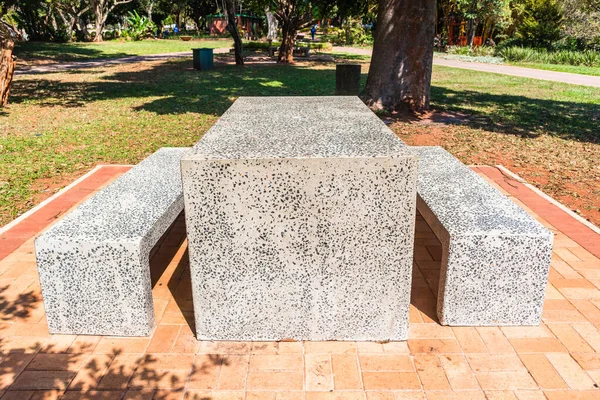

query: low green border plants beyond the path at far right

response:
[498,46,600,67]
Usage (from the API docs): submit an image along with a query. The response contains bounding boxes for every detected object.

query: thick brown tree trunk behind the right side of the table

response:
[361,0,436,112]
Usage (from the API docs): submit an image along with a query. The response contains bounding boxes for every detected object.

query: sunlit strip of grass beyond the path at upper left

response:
[15,39,233,64]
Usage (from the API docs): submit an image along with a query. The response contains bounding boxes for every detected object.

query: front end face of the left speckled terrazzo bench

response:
[36,242,155,336]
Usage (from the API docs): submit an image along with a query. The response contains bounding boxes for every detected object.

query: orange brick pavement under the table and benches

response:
[0,167,600,400]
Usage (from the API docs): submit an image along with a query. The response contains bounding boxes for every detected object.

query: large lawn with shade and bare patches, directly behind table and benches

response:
[0,57,600,225]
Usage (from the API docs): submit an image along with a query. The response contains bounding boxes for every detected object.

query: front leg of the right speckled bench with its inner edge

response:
[417,198,552,326]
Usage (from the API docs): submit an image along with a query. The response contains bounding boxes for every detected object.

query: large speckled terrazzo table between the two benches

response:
[182,97,418,340]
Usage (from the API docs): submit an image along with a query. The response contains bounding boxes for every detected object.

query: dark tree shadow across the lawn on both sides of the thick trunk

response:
[12,60,600,143]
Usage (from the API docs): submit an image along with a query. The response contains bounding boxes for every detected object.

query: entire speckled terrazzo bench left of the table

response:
[35,148,189,336]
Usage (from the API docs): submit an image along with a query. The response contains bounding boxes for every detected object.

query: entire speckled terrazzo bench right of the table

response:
[412,147,553,326]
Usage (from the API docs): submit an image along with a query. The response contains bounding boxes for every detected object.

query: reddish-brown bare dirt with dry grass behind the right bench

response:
[387,111,600,226]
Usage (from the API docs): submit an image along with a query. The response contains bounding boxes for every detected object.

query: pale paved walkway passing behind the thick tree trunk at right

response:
[333,47,600,87]
